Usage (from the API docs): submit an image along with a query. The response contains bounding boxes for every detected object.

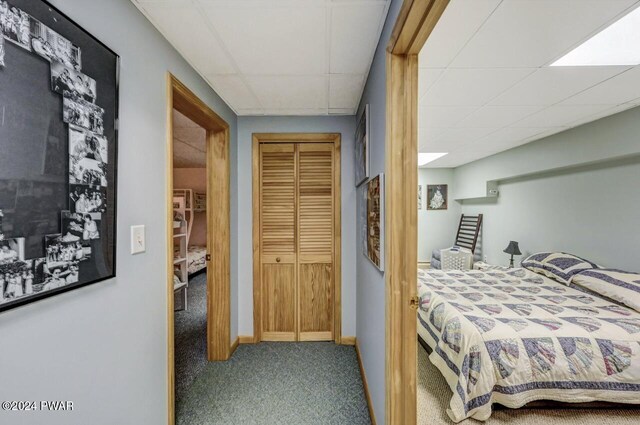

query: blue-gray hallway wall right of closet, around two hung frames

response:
[353,0,402,424]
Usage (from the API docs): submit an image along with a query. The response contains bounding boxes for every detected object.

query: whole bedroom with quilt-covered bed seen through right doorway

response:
[417,0,640,424]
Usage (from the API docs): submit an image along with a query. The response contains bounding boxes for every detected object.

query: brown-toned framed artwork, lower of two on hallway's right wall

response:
[367,173,384,271]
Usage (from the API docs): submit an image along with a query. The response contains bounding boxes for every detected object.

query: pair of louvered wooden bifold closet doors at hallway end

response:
[254,134,340,341]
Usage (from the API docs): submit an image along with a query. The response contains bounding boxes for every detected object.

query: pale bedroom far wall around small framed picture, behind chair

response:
[418,168,462,263]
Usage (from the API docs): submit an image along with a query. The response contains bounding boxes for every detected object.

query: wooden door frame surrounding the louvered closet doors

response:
[251,133,342,344]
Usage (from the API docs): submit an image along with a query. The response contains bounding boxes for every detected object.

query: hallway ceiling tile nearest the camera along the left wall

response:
[140,2,235,74]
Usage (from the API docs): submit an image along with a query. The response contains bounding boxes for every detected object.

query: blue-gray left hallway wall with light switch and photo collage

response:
[0,0,237,425]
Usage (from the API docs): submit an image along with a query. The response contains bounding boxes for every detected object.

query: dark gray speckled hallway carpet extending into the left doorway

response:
[175,274,371,425]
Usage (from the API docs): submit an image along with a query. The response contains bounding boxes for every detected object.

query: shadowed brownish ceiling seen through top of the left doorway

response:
[173,109,207,168]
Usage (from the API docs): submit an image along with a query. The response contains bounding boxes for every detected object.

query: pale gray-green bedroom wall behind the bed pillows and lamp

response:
[455,108,640,271]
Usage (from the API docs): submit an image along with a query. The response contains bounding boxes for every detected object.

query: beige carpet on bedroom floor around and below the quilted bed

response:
[418,344,640,425]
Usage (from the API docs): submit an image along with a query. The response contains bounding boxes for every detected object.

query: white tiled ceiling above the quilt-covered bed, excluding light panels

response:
[418,0,640,167]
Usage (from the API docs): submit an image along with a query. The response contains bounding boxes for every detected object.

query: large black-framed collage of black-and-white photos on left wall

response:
[0,0,120,312]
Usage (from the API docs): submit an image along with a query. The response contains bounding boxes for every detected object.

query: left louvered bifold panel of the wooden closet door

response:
[260,143,297,341]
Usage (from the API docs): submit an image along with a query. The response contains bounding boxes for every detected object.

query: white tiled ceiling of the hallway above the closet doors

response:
[132,0,390,115]
